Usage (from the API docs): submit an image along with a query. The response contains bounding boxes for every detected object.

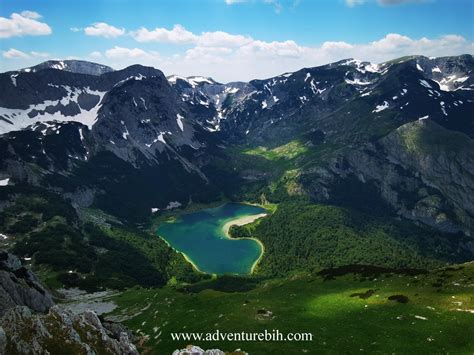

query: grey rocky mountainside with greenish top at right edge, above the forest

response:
[301,120,474,235]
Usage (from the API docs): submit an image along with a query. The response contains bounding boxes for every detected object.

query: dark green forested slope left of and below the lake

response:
[0,187,205,291]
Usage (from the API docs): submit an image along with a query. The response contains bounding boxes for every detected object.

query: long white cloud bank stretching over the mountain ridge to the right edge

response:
[47,30,474,82]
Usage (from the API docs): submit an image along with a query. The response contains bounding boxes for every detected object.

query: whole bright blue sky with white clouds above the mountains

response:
[0,0,474,81]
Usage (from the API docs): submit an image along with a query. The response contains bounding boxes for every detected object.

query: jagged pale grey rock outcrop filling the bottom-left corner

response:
[0,306,138,355]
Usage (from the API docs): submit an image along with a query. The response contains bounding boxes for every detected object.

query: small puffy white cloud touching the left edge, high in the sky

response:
[0,11,52,38]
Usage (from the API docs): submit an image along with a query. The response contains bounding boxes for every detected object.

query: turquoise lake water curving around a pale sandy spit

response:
[157,203,266,274]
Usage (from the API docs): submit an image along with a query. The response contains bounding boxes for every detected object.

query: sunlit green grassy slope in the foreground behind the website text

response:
[108,263,474,354]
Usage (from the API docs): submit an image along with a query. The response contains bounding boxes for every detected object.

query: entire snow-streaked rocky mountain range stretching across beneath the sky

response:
[0,55,474,231]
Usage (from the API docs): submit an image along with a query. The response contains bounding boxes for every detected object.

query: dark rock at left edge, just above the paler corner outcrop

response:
[0,251,54,316]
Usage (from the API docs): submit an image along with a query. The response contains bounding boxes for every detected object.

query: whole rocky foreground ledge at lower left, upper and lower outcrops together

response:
[0,251,138,355]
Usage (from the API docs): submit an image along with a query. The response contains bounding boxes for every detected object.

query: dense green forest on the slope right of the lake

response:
[231,201,468,276]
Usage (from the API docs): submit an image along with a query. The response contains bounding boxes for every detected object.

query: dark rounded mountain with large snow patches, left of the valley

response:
[0,65,222,219]
